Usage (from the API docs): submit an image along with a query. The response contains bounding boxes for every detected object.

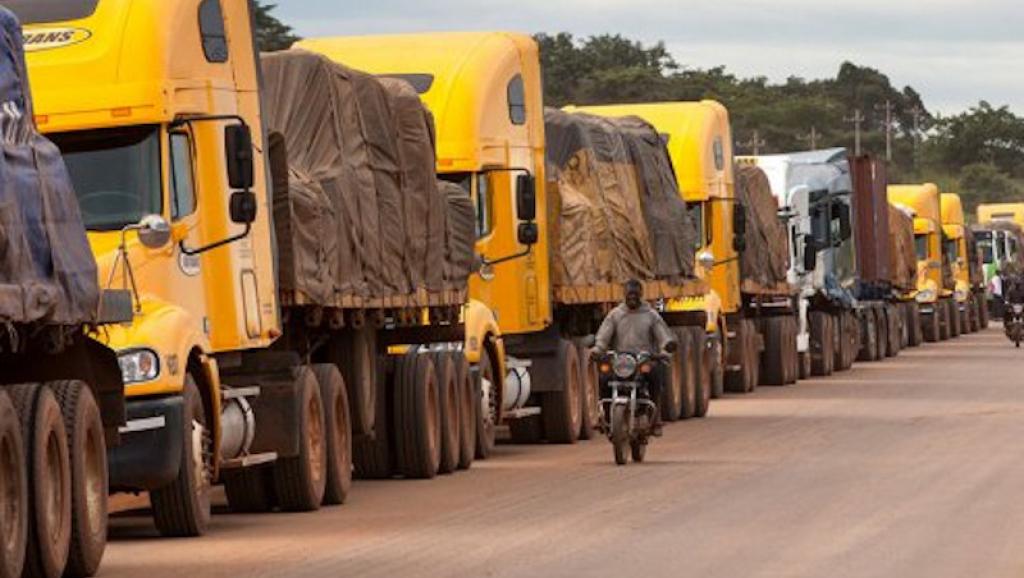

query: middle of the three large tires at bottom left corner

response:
[4,383,72,578]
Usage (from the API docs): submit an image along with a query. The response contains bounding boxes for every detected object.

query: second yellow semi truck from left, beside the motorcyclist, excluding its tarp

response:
[297,32,711,443]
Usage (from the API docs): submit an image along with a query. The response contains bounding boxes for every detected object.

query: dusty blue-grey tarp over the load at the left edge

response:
[0,8,99,326]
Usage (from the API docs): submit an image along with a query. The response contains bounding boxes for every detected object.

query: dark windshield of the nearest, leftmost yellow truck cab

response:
[48,126,162,231]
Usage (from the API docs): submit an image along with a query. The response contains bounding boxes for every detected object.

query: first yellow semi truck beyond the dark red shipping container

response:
[889,182,953,341]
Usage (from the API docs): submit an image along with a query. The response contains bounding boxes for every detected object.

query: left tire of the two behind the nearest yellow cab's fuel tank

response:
[273,366,328,511]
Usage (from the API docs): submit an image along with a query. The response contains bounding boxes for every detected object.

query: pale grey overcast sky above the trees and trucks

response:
[275,0,1024,114]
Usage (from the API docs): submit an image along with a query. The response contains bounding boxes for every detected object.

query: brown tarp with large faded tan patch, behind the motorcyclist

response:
[545,109,695,286]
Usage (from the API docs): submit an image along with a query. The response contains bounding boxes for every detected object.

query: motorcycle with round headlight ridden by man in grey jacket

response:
[598,352,662,465]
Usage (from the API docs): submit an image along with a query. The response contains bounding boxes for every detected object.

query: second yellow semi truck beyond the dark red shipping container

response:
[939,193,982,335]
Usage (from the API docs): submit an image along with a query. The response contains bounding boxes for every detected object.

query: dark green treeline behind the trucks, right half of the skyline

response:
[536,33,1024,210]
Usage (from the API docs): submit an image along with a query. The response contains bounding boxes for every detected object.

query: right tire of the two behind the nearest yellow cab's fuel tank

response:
[311,363,352,505]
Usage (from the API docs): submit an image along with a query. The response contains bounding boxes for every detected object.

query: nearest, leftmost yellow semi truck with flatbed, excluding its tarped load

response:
[24,0,486,536]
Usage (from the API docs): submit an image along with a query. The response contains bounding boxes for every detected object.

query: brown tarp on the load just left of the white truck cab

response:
[736,165,790,288]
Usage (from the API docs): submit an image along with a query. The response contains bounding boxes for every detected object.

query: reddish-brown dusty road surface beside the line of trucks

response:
[101,328,1024,578]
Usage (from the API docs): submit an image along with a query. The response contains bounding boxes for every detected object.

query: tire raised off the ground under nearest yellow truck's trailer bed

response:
[325,327,378,436]
